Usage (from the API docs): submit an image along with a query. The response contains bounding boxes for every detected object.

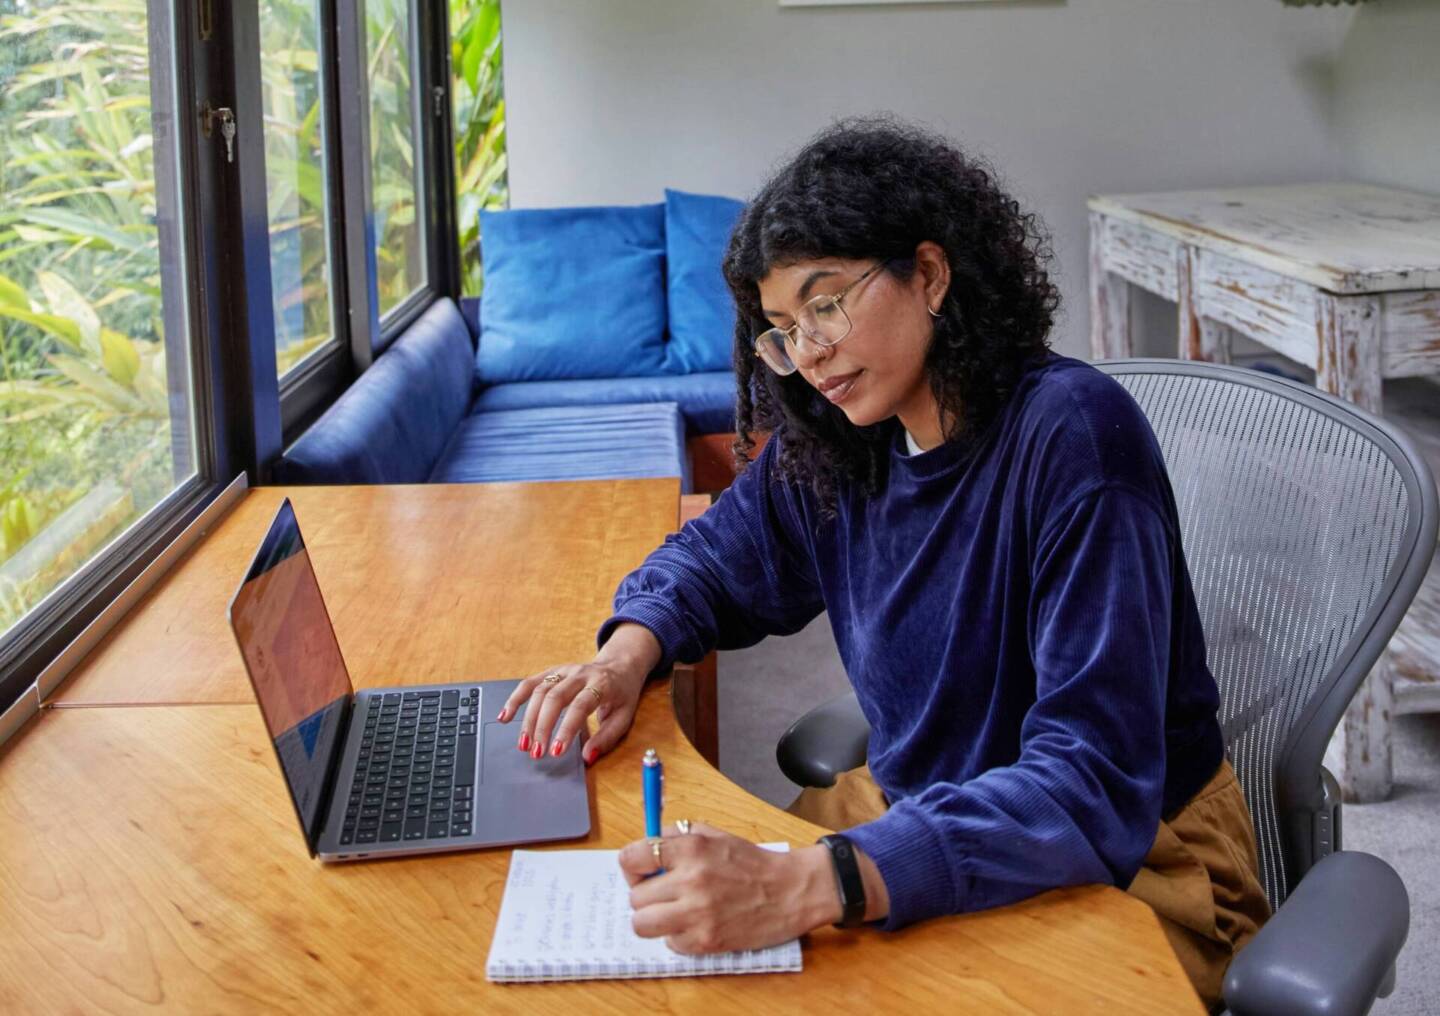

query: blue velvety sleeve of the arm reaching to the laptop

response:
[596,437,824,669]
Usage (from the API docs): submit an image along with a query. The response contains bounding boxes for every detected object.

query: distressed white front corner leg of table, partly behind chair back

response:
[1315,292,1395,802]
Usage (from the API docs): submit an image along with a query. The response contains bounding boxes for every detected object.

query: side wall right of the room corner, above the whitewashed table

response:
[1335,0,1440,193]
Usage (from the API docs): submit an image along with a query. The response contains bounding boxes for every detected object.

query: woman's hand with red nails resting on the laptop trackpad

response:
[498,625,660,766]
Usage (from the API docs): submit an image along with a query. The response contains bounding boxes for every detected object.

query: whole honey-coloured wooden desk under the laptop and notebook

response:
[0,484,1201,1013]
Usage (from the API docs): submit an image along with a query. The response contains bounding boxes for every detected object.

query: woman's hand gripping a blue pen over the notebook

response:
[619,822,841,954]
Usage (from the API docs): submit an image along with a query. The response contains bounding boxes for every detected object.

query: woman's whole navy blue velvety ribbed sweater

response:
[599,355,1224,928]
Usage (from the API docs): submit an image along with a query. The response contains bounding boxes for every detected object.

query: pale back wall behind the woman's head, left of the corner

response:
[504,0,1347,355]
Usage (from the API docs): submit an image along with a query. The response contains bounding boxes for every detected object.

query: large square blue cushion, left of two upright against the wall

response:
[475,204,665,383]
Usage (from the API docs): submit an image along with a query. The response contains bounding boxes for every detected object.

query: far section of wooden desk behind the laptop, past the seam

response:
[50,479,680,705]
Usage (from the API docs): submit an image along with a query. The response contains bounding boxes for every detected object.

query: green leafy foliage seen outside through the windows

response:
[0,0,507,633]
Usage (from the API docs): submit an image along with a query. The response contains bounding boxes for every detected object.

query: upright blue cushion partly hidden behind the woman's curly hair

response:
[665,190,744,374]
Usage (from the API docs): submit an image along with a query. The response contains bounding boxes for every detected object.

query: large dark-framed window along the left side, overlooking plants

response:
[0,0,460,709]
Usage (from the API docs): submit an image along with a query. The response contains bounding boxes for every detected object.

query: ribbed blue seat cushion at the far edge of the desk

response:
[431,402,690,492]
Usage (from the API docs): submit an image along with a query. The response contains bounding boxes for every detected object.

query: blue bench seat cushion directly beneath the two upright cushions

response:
[474,370,734,435]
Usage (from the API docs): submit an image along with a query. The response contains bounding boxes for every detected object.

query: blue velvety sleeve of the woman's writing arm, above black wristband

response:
[848,482,1178,928]
